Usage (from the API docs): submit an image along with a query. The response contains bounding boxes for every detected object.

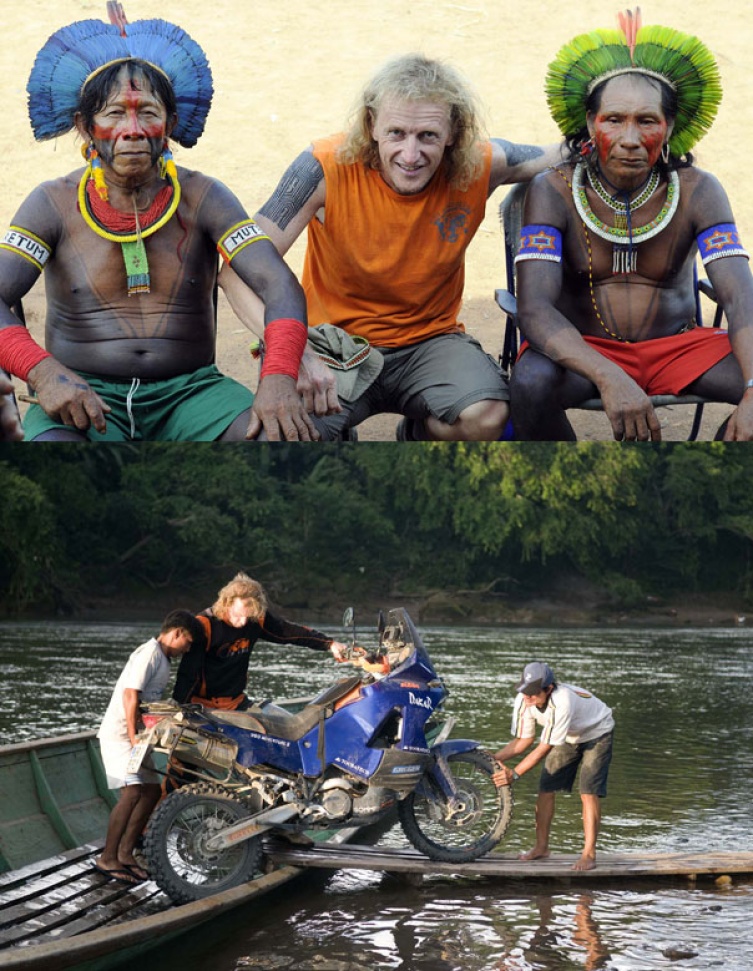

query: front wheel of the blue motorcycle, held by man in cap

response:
[397,749,513,863]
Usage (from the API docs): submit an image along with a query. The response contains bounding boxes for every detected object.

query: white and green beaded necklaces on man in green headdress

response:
[572,162,680,274]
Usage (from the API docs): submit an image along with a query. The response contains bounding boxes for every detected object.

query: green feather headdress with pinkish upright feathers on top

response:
[545,9,722,156]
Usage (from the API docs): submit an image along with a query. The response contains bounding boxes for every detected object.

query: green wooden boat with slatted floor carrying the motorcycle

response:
[0,732,368,971]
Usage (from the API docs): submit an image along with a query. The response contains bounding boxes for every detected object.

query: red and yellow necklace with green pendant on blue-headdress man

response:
[78,149,181,297]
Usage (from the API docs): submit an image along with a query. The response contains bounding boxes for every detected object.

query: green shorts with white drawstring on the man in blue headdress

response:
[24,364,254,442]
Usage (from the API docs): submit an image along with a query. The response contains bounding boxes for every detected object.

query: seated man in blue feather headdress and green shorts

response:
[0,3,318,441]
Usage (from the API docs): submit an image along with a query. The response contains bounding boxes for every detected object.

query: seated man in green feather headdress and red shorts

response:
[511,10,753,441]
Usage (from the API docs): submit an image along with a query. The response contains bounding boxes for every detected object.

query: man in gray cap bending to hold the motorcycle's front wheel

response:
[493,661,614,870]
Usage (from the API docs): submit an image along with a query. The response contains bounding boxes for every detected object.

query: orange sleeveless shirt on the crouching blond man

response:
[302,135,492,347]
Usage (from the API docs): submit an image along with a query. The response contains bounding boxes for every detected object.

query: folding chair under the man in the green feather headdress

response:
[494,183,724,442]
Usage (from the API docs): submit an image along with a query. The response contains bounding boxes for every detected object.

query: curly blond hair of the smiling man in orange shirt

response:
[338,54,483,189]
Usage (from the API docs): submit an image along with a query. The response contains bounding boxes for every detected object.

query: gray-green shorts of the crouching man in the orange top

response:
[308,333,510,440]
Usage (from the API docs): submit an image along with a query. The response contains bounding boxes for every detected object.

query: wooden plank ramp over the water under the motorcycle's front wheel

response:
[267,841,753,881]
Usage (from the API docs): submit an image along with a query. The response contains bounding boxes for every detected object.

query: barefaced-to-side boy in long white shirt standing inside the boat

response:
[94,610,202,884]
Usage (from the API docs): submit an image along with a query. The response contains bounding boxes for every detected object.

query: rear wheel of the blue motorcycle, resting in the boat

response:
[144,783,262,904]
